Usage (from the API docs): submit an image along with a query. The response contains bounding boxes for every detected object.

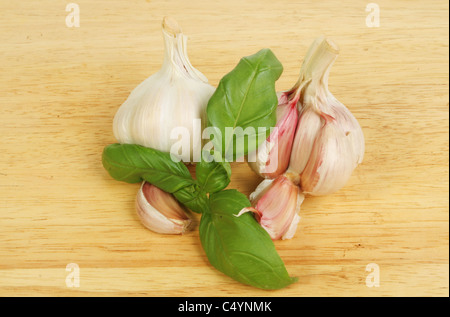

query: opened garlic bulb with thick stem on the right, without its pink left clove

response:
[288,38,364,195]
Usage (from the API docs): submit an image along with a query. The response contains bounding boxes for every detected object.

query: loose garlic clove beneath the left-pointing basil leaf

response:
[136,181,192,234]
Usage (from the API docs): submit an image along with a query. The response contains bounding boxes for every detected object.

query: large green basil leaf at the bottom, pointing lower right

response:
[199,189,297,289]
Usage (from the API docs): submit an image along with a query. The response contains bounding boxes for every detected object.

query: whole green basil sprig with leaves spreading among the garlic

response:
[102,49,296,289]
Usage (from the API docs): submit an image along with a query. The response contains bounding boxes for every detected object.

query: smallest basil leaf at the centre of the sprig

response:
[195,156,231,193]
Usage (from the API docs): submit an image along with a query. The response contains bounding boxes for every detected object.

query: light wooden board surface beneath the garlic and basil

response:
[0,0,449,296]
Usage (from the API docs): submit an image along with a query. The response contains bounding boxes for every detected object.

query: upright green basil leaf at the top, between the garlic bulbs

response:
[207,49,283,161]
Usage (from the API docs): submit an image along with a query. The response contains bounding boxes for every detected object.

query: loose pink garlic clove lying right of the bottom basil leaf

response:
[237,173,305,240]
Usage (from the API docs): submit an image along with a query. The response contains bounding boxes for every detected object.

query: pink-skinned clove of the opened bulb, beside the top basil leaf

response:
[247,92,298,179]
